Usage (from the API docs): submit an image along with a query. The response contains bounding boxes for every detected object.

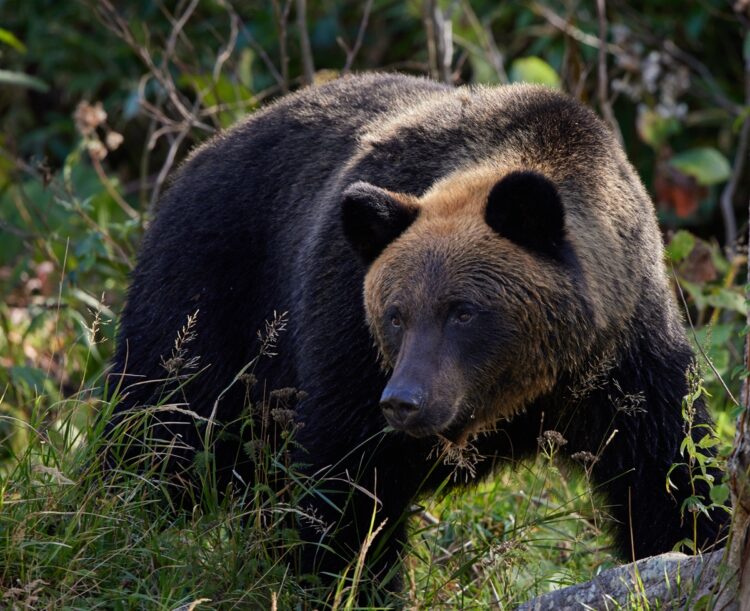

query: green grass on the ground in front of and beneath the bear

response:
[0,356,632,609]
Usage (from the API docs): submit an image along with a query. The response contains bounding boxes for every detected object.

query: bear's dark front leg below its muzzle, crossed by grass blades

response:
[298,433,427,596]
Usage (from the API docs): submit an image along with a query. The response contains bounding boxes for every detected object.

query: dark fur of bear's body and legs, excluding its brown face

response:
[108,75,723,588]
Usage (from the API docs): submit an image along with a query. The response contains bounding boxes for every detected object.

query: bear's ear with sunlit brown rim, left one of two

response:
[341,182,419,265]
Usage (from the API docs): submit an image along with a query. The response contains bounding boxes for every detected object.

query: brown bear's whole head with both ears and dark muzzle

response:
[342,168,585,443]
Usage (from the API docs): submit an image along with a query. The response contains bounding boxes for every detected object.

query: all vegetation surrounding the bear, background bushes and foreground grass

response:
[0,0,750,609]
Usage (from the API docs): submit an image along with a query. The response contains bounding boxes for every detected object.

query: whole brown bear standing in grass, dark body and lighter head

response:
[108,74,726,587]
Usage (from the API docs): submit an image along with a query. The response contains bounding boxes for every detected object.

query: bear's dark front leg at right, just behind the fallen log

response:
[561,348,728,560]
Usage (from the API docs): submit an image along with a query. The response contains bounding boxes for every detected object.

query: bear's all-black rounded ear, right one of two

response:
[485,172,565,259]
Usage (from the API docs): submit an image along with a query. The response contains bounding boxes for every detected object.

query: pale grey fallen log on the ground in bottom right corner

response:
[517,550,739,611]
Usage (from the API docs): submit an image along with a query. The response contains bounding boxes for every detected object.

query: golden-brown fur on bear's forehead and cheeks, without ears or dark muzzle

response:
[365,166,584,441]
